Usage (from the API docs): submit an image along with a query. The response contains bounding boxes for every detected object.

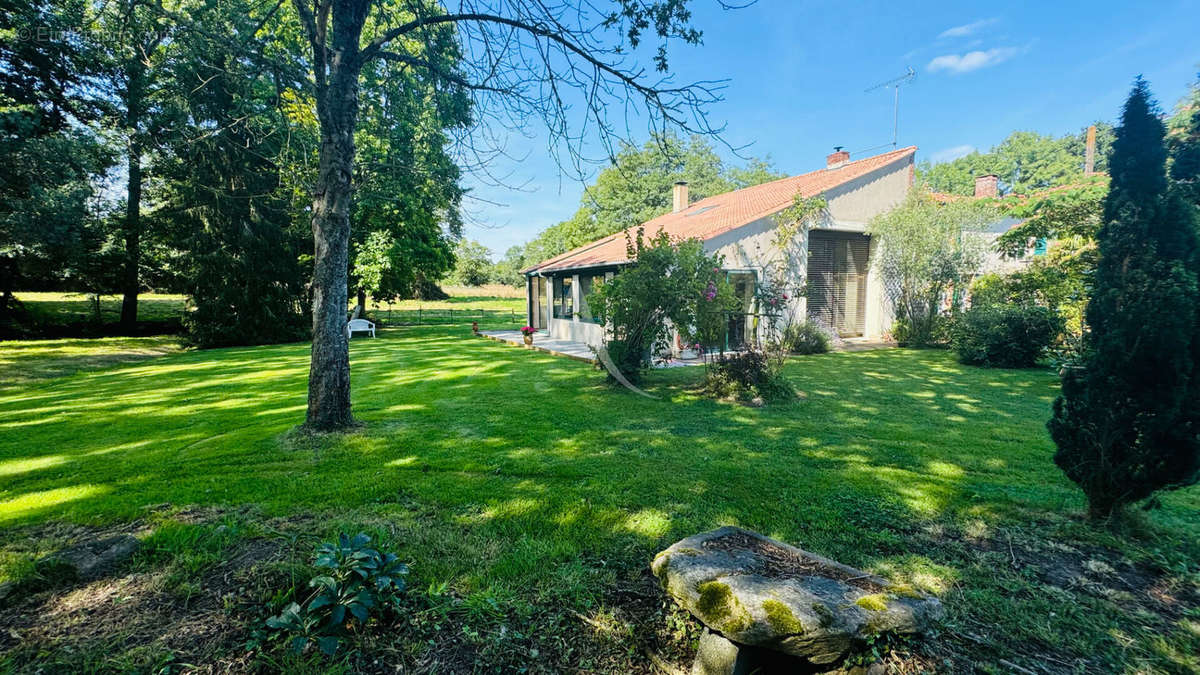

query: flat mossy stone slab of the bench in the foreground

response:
[650,527,942,665]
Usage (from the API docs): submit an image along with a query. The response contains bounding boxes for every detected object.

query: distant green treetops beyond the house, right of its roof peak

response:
[918,121,1112,196]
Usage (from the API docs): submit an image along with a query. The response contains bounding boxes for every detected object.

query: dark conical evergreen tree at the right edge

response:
[1048,77,1200,520]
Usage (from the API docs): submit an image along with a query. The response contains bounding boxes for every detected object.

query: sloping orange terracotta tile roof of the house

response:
[522,147,917,273]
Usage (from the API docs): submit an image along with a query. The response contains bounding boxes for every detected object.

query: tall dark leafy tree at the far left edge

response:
[0,0,113,317]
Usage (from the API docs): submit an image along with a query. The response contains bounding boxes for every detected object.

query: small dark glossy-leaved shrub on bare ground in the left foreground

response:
[266,533,408,655]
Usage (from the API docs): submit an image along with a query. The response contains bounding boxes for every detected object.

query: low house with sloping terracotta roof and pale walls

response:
[522,147,917,348]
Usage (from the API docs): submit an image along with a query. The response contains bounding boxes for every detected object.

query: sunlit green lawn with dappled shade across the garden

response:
[0,327,1200,673]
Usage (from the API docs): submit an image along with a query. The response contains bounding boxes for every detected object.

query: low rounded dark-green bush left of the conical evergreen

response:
[952,305,1062,368]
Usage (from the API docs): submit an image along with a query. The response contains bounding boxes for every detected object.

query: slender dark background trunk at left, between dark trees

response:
[121,59,145,329]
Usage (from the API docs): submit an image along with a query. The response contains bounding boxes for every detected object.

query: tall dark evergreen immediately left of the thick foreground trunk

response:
[158,6,311,347]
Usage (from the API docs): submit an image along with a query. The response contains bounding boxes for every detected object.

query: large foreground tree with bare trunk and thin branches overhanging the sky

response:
[293,0,729,430]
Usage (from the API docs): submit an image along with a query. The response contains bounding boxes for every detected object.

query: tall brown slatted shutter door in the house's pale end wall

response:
[808,231,871,338]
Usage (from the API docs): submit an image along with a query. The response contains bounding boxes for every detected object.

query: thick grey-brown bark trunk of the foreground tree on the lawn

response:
[305,0,366,431]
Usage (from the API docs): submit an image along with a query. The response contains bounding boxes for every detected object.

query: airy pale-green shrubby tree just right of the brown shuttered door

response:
[868,189,996,347]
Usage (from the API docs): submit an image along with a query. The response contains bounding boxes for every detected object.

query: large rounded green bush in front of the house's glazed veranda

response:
[587,232,737,381]
